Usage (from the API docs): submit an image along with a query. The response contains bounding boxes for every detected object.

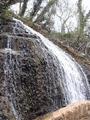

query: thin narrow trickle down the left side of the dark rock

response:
[1,35,20,120]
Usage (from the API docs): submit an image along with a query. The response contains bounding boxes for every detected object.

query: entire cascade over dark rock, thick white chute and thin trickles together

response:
[0,19,90,120]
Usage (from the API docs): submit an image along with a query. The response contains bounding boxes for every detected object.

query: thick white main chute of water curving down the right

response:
[14,19,89,104]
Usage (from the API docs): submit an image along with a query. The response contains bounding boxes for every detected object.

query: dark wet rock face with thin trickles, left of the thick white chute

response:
[0,21,64,120]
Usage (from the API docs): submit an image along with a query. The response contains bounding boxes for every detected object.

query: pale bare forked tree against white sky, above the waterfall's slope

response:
[56,0,73,34]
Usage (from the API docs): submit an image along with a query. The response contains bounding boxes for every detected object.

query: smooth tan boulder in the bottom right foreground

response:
[35,101,90,120]
